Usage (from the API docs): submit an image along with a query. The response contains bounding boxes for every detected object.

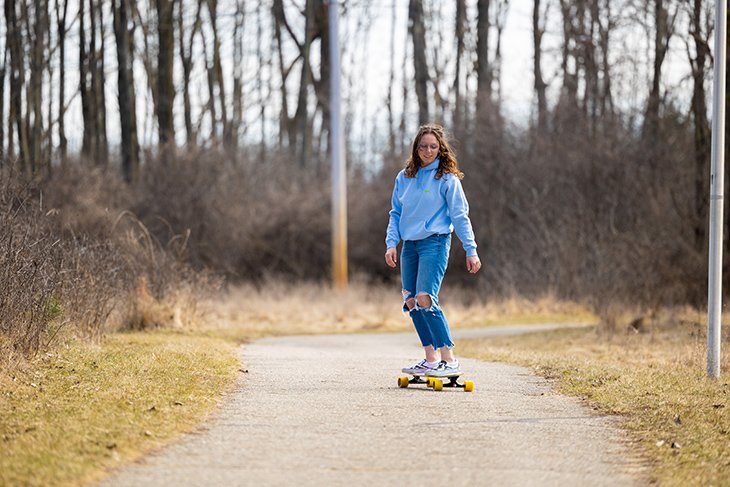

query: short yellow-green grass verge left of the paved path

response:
[0,332,238,485]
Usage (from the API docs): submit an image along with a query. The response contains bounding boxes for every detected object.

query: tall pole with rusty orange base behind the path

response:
[327,0,347,289]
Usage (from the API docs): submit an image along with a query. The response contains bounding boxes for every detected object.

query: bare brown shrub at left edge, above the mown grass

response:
[0,163,219,364]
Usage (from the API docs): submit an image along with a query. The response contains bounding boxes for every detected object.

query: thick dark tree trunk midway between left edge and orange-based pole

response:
[156,0,175,146]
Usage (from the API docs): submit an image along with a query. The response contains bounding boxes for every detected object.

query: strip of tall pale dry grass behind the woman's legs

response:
[198,280,595,341]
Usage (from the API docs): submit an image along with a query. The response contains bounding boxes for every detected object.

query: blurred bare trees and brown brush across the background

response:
[0,0,730,348]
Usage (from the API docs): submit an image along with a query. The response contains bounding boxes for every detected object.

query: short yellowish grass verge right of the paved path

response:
[459,325,730,486]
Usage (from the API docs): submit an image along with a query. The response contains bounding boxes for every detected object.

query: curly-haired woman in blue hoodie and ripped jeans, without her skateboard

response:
[385,125,482,377]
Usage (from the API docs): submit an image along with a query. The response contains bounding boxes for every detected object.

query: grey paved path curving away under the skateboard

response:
[102,326,645,486]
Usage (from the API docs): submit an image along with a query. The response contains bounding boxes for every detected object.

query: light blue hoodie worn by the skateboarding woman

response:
[385,159,477,256]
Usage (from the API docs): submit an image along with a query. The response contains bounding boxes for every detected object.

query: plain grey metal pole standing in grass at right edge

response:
[707,0,727,379]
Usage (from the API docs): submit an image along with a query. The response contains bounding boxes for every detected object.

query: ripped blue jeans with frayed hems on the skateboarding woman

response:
[400,234,454,349]
